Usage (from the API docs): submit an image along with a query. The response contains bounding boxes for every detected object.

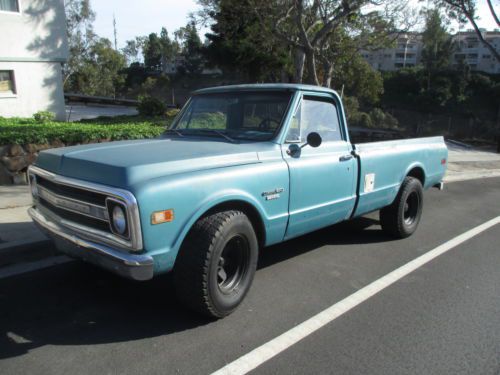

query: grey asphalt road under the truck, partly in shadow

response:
[0,179,500,375]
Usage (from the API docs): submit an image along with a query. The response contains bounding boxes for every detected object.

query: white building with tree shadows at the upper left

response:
[0,0,68,120]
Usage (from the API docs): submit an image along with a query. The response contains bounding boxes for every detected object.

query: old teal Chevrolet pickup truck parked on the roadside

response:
[29,84,448,318]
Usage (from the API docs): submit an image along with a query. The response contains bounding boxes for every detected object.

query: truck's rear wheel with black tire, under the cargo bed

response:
[380,176,424,238]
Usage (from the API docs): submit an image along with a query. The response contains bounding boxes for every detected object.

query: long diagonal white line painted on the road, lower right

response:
[212,216,500,375]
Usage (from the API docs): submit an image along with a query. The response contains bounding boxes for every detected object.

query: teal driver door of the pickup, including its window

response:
[282,95,357,239]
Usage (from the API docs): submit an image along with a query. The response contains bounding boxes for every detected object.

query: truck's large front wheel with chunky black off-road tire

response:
[174,211,259,318]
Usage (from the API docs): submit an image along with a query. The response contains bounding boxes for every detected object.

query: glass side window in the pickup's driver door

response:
[287,97,342,142]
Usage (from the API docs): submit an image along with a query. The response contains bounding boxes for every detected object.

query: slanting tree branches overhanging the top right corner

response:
[436,0,500,62]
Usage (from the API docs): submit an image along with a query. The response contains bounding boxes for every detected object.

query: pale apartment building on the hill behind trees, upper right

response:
[361,30,500,74]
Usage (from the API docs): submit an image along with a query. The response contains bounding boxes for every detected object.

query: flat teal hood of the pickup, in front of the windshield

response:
[35,138,262,188]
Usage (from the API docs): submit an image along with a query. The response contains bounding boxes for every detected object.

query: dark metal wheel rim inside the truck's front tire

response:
[217,235,249,294]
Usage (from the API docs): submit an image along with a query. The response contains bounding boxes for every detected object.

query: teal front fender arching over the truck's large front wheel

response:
[134,162,288,273]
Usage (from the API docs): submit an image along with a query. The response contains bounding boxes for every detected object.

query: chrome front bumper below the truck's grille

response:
[28,207,153,280]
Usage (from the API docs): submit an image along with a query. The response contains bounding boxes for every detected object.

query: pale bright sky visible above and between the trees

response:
[91,0,500,48]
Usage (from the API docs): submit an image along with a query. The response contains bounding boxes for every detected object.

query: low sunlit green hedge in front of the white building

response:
[0,116,172,145]
